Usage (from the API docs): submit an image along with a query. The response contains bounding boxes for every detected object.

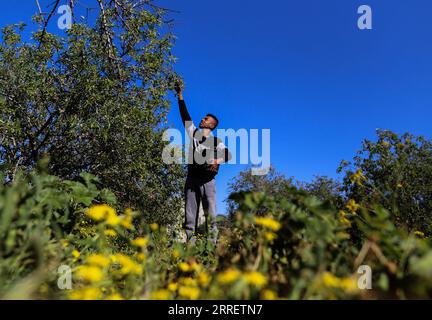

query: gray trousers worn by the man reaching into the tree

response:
[184,176,217,243]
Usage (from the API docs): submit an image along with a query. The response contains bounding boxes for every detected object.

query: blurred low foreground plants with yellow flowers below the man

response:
[0,165,432,299]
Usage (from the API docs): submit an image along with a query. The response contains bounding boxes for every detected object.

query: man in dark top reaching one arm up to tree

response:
[176,84,231,244]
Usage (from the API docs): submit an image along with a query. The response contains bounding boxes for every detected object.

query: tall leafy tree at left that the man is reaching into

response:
[0,0,184,224]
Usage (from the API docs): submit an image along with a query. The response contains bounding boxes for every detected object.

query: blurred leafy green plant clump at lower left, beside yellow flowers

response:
[0,159,116,298]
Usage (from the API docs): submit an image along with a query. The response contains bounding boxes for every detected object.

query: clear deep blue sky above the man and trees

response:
[0,0,432,213]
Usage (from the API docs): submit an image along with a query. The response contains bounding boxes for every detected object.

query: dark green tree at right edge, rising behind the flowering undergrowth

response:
[339,130,432,234]
